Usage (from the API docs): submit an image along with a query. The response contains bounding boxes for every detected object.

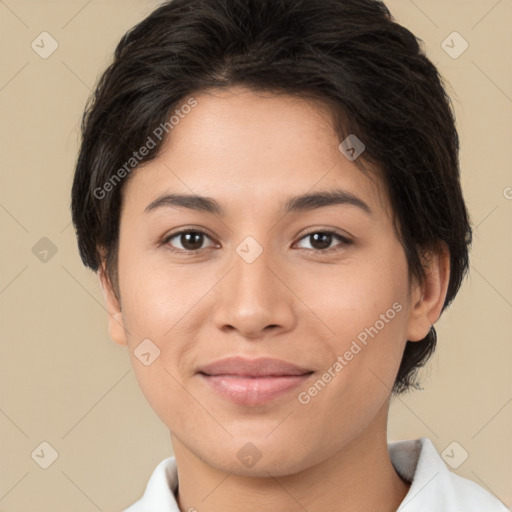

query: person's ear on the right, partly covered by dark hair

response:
[407,243,450,341]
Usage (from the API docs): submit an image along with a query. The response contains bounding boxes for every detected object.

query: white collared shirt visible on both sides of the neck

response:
[123,437,510,512]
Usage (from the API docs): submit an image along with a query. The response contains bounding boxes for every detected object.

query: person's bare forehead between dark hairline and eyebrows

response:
[123,87,389,218]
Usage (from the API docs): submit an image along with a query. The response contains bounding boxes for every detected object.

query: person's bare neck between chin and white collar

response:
[171,404,409,512]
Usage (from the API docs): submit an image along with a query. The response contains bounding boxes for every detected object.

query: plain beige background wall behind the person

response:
[0,0,512,512]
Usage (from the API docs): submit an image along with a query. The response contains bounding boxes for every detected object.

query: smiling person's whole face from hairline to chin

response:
[104,88,440,475]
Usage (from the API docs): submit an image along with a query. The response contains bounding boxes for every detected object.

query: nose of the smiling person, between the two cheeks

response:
[213,244,297,339]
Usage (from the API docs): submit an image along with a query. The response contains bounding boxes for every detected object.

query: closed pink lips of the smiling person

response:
[198,357,313,405]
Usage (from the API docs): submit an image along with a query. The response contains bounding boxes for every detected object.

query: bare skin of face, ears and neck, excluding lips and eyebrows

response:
[99,87,449,512]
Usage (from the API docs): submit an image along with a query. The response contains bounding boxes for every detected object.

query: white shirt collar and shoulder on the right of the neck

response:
[388,437,510,512]
